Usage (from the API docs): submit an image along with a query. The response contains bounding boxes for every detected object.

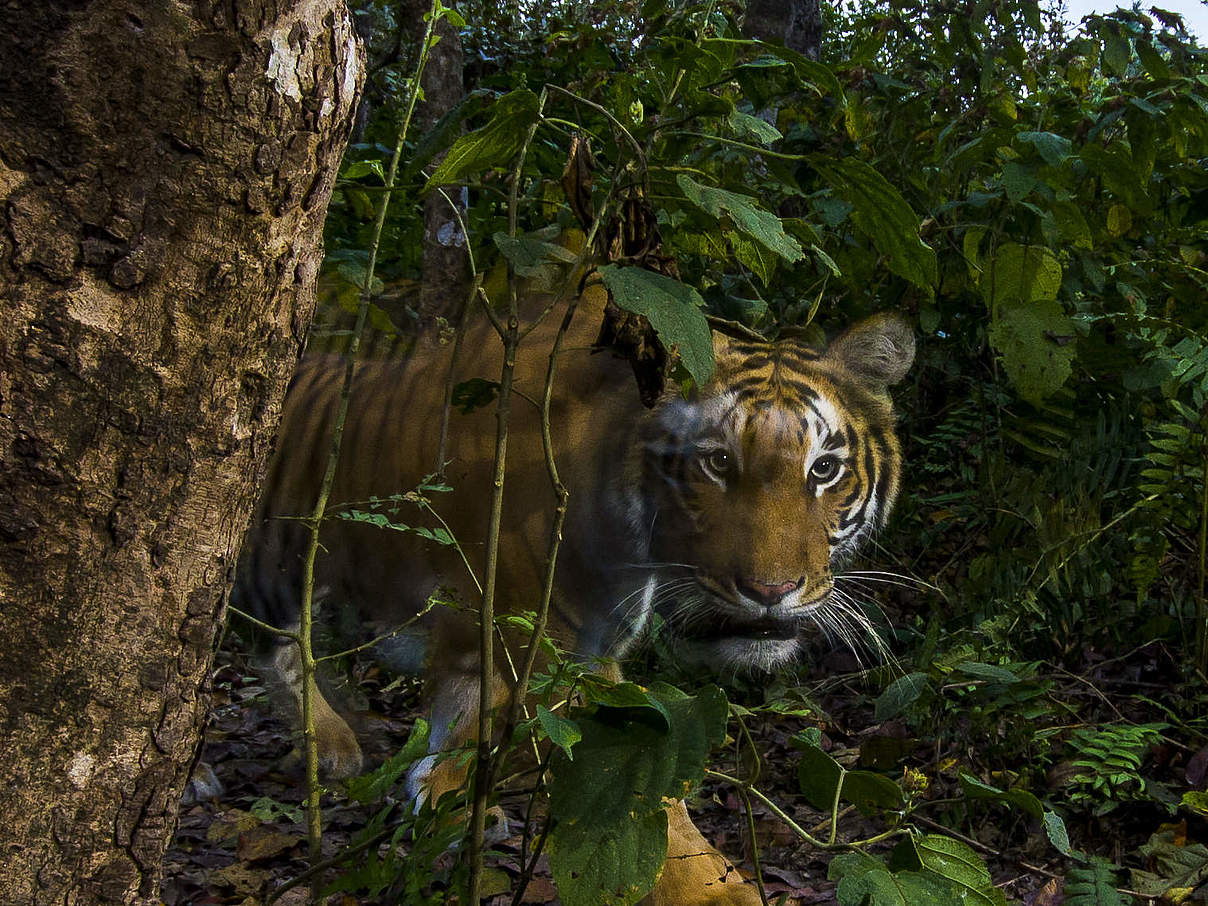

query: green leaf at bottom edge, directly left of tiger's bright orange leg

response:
[550,808,667,906]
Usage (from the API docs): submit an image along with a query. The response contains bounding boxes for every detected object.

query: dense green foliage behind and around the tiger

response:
[299,0,1208,906]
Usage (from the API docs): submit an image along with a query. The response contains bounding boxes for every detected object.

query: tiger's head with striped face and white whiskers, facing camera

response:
[633,314,914,670]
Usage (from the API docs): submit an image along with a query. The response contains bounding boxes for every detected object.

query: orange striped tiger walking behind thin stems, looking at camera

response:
[234,284,914,906]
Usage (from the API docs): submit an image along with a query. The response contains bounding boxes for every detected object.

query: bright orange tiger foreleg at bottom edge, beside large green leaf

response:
[641,801,762,906]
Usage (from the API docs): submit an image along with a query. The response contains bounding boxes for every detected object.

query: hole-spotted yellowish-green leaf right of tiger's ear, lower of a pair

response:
[989,300,1075,402]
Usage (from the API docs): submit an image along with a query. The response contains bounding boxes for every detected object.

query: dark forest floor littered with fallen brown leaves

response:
[162,637,1208,906]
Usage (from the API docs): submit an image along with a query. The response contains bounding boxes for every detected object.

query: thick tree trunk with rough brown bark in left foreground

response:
[0,0,361,905]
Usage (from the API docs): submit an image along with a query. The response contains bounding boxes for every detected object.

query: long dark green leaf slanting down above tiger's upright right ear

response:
[811,156,939,294]
